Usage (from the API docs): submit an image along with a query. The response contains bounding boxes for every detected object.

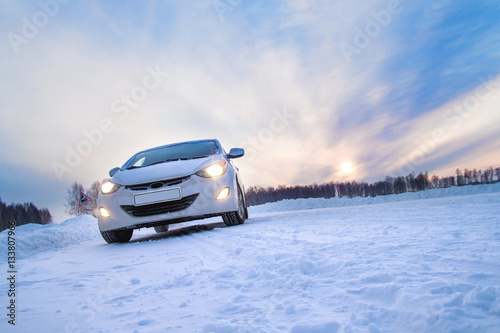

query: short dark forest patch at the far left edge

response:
[0,198,52,231]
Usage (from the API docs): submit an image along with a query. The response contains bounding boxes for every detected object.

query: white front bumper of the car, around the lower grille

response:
[97,168,238,231]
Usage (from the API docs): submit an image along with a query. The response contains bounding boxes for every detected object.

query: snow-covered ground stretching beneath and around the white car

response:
[0,184,500,333]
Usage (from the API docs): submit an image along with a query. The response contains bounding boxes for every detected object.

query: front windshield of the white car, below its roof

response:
[122,141,217,169]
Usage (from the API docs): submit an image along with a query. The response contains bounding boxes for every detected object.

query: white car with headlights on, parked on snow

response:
[97,140,248,243]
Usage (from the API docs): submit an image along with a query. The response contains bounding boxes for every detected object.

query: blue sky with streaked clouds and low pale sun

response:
[0,0,500,222]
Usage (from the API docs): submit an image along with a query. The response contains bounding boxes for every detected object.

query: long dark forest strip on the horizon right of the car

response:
[245,167,500,206]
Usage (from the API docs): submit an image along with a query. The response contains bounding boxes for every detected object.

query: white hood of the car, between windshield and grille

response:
[111,155,223,185]
